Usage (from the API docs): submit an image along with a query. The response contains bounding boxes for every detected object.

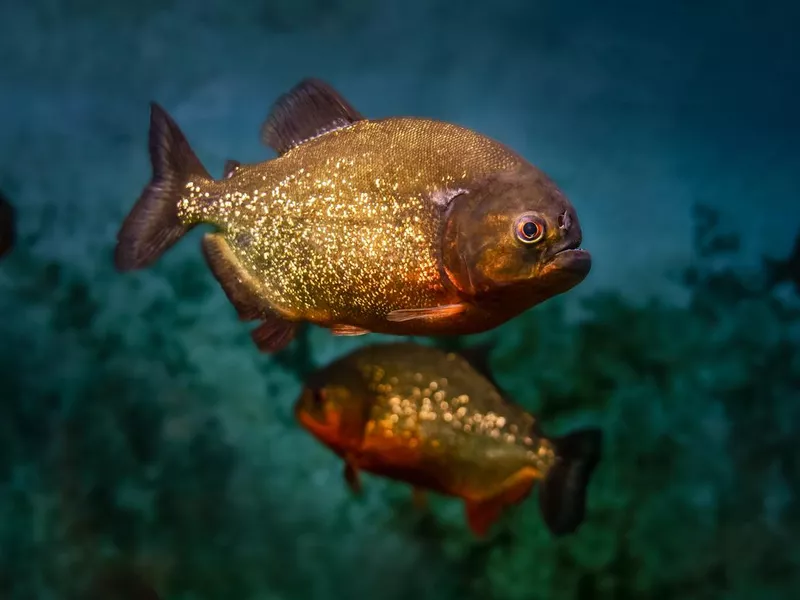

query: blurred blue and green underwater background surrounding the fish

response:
[0,0,800,600]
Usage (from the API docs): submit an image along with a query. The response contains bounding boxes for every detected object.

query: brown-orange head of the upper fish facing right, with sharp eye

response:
[442,165,592,310]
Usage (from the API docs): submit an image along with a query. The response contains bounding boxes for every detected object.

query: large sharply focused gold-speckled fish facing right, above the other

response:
[114,79,591,353]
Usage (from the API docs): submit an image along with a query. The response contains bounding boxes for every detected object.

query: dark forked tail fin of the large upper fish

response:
[114,102,212,271]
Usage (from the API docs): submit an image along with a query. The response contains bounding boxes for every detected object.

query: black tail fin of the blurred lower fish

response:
[539,428,603,536]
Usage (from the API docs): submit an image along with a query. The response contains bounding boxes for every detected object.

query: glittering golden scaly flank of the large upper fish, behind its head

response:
[178,118,519,322]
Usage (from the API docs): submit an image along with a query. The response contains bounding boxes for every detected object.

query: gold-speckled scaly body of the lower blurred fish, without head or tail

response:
[357,344,553,498]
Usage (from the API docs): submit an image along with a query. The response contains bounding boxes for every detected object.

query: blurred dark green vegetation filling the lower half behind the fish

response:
[0,204,800,600]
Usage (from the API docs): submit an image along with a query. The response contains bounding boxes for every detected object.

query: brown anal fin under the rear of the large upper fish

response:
[202,233,297,353]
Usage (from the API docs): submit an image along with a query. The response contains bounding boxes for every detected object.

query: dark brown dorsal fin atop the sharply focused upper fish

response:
[261,79,364,154]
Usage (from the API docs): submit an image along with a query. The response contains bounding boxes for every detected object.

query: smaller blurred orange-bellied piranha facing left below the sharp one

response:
[295,342,602,536]
